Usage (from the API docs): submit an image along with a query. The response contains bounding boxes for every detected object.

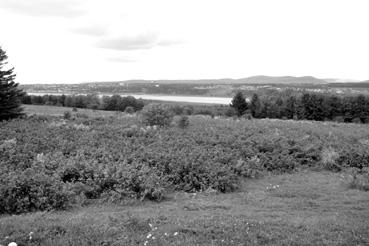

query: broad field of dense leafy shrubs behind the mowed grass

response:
[0,106,369,214]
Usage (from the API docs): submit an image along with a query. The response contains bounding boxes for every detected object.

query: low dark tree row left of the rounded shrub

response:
[22,94,144,111]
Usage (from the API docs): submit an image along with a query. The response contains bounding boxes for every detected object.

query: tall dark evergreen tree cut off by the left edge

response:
[0,47,24,121]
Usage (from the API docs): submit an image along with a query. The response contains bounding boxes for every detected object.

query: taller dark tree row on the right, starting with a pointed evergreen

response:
[231,92,369,123]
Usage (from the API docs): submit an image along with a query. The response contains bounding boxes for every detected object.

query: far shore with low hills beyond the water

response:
[21,76,369,97]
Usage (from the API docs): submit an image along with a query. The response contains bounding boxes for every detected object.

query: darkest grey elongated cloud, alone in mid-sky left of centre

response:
[96,33,181,50]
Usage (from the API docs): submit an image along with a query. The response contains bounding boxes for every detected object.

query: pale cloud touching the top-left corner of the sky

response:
[0,0,85,17]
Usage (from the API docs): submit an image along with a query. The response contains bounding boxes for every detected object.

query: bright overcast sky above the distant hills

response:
[0,0,369,83]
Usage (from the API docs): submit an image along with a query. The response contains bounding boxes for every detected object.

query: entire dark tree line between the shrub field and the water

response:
[22,91,369,123]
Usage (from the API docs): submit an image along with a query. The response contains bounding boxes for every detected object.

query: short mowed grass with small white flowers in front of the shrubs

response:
[0,171,369,245]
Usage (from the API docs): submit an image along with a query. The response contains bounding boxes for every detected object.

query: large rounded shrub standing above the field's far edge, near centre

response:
[142,103,173,126]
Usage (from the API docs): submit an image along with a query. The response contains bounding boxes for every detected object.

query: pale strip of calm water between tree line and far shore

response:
[28,93,232,105]
